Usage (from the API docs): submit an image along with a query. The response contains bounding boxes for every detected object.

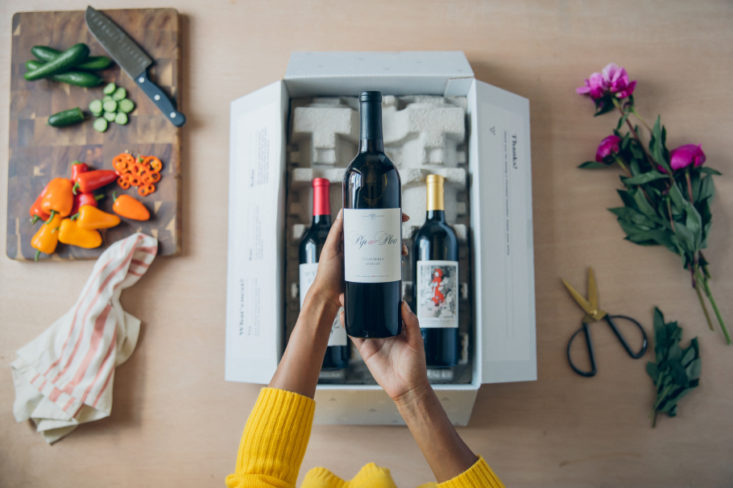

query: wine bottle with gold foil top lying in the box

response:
[412,175,458,368]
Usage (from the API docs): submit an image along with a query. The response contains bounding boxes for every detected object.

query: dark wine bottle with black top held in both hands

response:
[343,91,402,337]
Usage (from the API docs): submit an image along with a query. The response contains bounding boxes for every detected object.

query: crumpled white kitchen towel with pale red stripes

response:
[11,233,158,444]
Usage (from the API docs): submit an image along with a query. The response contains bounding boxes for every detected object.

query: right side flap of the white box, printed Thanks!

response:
[468,81,537,383]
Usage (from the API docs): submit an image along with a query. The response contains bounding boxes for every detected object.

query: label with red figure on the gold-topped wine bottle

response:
[415,261,458,328]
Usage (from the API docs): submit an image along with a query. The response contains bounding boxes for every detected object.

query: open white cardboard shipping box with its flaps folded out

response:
[225,51,537,425]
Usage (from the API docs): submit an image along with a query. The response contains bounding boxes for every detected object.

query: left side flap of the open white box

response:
[225,81,288,383]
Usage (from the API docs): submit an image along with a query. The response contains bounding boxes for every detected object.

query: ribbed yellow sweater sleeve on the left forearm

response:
[226,388,315,488]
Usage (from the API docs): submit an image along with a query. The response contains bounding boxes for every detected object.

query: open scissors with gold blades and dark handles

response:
[562,267,648,377]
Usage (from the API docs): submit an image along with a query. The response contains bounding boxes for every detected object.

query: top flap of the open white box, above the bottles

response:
[285,51,473,97]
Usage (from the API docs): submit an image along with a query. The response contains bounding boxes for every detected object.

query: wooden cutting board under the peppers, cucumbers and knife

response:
[6,8,185,260]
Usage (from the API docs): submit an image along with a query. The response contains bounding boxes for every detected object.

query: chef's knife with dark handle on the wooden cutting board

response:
[84,7,186,127]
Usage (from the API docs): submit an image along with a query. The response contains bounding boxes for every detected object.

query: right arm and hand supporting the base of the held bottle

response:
[352,302,503,488]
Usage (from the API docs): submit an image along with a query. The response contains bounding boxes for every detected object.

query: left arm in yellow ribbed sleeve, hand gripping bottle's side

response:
[226,213,343,488]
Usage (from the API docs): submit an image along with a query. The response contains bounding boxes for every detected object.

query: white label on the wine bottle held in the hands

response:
[344,208,402,283]
